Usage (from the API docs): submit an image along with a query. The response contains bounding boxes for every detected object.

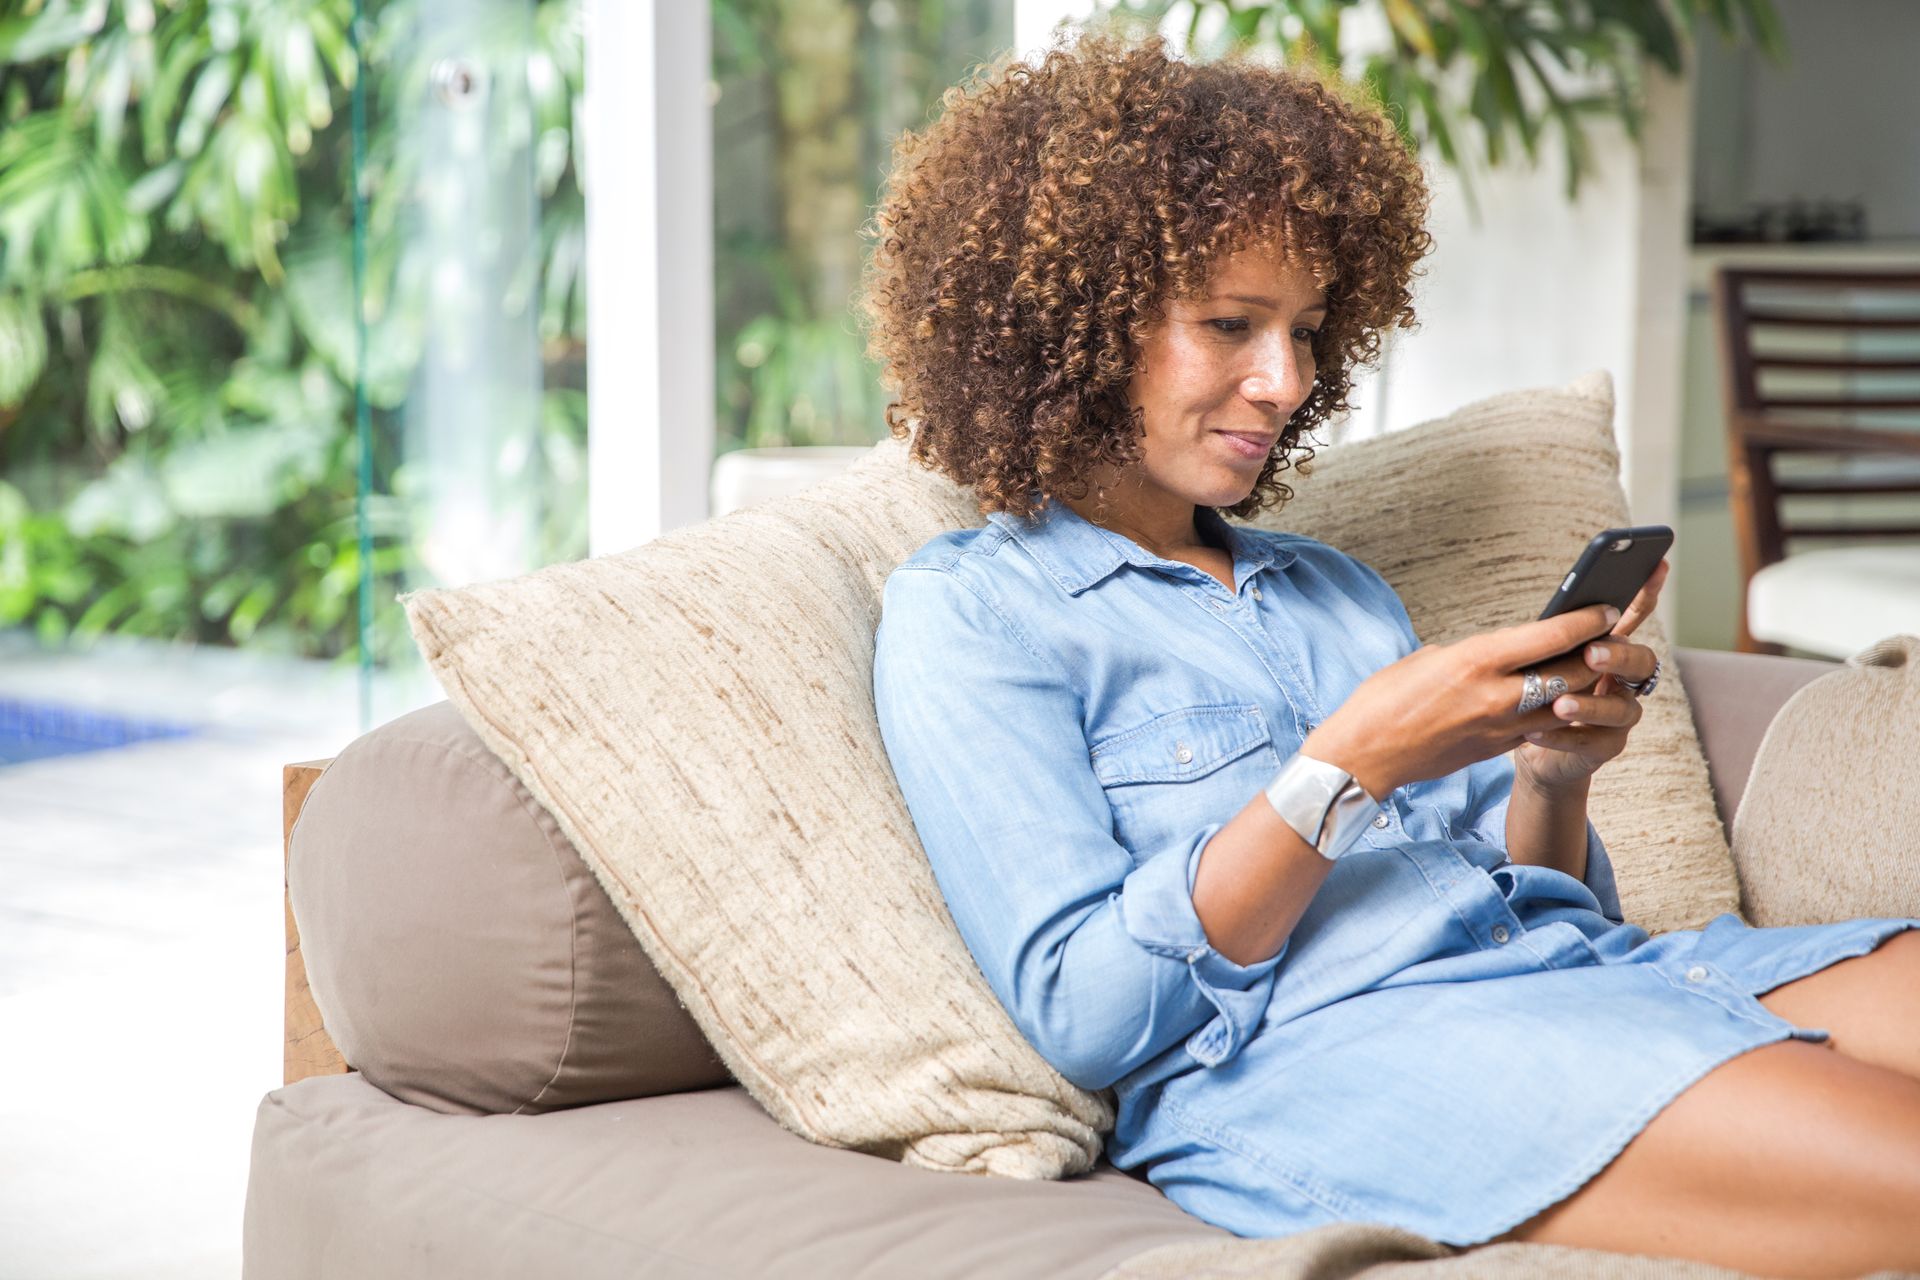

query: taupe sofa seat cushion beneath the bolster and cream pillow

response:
[246,1073,1233,1280]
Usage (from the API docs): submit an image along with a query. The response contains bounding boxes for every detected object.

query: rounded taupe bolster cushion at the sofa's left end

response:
[286,702,732,1115]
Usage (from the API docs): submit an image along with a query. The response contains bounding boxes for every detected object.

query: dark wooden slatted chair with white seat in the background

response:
[1715,267,1920,658]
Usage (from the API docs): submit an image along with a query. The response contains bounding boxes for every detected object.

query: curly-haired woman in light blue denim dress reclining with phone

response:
[868,25,1920,1276]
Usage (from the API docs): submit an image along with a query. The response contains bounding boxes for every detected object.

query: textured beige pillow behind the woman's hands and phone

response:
[1252,372,1740,933]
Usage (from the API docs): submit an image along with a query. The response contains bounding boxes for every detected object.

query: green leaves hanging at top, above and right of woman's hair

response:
[1098,0,1786,200]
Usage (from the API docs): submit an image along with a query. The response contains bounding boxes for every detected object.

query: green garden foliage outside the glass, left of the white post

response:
[0,0,586,658]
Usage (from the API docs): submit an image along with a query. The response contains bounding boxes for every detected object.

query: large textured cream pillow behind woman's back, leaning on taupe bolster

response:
[407,452,1114,1178]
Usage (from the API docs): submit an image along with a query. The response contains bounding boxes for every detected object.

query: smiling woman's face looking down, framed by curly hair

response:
[1127,237,1327,510]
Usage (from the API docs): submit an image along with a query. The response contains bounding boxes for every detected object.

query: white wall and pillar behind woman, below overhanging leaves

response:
[1332,77,1692,556]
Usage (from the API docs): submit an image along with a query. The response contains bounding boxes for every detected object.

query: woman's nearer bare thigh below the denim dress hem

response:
[1488,1043,1920,1278]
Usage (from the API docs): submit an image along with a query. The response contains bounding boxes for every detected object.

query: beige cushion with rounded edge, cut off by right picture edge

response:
[1734,635,1920,925]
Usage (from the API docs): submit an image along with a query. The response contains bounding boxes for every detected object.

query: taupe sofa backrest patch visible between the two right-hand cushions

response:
[1655,649,1839,833]
